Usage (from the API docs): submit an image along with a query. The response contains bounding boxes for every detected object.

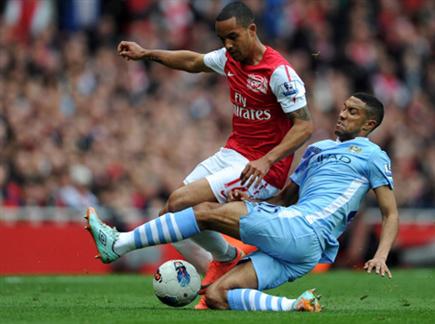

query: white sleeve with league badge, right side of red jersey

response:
[270,65,307,113]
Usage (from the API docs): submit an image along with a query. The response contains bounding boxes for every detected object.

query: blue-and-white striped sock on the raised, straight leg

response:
[114,208,200,255]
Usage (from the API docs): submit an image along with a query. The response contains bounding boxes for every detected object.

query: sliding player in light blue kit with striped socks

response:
[86,93,399,311]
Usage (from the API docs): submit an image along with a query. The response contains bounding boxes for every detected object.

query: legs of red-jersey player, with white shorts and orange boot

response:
[167,158,252,309]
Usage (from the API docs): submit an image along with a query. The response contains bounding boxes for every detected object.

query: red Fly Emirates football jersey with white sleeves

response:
[204,47,306,188]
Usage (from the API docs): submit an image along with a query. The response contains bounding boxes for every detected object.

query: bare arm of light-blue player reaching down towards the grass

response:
[364,186,399,278]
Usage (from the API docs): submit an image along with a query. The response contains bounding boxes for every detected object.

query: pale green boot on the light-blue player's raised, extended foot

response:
[85,207,120,263]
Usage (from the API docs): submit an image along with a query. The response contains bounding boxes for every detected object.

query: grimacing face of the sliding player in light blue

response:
[334,97,376,141]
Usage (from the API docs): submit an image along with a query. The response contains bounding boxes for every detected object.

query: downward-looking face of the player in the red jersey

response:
[216,17,257,62]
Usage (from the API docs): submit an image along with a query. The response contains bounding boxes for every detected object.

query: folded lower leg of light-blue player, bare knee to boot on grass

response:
[206,252,320,312]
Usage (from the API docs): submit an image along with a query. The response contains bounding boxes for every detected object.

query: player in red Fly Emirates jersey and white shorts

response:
[118,2,313,308]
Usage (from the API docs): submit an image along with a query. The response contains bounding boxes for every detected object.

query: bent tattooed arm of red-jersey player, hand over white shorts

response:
[240,106,313,187]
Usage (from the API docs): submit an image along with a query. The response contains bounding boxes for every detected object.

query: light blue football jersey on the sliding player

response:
[290,137,393,262]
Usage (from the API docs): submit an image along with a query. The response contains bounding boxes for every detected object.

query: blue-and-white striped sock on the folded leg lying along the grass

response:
[227,289,295,311]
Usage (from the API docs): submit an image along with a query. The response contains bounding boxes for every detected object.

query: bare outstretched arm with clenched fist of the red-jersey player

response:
[117,41,212,73]
